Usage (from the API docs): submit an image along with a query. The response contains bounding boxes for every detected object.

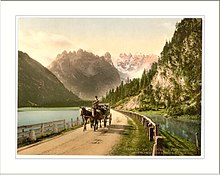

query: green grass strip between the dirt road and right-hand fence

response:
[111,117,153,156]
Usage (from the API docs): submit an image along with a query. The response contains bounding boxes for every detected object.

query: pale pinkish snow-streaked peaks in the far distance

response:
[116,53,158,80]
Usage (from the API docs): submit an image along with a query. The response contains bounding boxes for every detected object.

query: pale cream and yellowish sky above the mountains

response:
[18,17,181,66]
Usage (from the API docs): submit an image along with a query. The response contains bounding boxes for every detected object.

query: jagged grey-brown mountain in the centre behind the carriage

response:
[48,49,121,100]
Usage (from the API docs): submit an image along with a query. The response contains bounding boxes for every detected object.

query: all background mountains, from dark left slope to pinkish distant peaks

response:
[18,49,157,107]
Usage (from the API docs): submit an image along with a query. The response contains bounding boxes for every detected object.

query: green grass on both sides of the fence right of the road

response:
[111,110,200,156]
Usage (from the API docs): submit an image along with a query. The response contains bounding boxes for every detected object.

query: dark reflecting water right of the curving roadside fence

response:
[144,114,201,143]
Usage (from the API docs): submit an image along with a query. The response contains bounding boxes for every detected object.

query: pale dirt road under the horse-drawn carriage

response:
[17,110,127,156]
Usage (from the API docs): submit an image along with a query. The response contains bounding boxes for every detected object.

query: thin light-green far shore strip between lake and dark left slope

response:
[18,107,79,112]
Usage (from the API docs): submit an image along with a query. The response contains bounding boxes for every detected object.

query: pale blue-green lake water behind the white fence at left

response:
[17,110,81,126]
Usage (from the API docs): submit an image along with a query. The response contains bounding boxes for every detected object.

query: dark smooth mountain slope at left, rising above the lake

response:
[18,51,80,107]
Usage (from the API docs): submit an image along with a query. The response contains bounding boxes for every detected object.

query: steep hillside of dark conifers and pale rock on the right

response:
[103,18,202,115]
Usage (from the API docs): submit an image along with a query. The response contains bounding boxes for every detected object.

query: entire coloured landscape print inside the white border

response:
[17,16,203,158]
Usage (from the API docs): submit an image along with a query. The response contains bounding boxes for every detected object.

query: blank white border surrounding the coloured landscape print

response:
[0,1,219,174]
